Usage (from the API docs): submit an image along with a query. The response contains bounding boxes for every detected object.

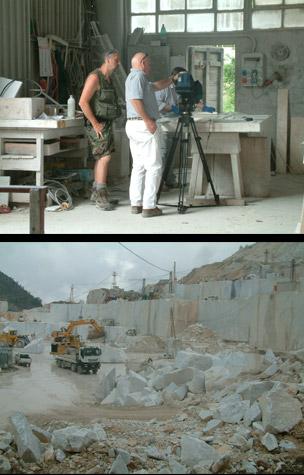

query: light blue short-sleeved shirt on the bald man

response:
[126,69,159,119]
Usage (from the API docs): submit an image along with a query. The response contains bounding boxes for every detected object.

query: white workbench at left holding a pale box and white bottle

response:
[0,118,86,202]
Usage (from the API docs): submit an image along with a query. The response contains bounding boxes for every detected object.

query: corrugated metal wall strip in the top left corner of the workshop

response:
[0,0,30,80]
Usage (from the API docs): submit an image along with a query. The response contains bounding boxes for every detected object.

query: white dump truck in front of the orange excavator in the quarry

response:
[51,343,101,374]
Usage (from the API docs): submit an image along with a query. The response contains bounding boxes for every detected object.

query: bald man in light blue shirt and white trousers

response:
[126,52,172,218]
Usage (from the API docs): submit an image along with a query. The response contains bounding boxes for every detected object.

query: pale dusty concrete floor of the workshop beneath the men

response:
[0,175,304,235]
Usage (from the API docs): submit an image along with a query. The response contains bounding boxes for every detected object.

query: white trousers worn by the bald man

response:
[126,120,162,209]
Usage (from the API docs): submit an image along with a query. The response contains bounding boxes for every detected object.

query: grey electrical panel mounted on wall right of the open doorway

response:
[240,53,265,87]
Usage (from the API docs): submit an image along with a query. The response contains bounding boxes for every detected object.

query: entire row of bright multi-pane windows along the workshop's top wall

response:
[129,0,304,34]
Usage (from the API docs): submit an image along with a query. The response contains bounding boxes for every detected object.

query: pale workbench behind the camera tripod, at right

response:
[160,112,271,206]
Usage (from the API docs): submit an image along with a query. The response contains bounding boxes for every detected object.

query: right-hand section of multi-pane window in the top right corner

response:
[252,0,304,29]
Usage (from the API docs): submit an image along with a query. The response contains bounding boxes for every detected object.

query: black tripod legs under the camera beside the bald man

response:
[157,110,220,214]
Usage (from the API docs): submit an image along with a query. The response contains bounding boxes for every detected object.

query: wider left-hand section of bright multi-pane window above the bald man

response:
[130,0,244,33]
